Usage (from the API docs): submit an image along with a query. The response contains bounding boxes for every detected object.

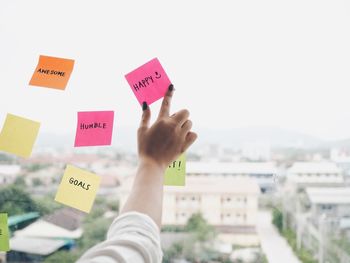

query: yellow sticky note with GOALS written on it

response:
[55,165,101,213]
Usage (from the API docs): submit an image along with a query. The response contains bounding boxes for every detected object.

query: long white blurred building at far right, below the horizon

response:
[287,162,344,190]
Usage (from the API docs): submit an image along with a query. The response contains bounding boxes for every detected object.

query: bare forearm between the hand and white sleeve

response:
[121,160,165,228]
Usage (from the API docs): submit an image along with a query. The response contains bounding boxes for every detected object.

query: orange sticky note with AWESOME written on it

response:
[29,56,74,90]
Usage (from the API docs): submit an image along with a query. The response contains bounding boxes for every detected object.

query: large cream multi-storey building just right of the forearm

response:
[120,175,260,245]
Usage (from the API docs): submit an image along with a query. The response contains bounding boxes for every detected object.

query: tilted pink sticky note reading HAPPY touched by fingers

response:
[125,58,171,105]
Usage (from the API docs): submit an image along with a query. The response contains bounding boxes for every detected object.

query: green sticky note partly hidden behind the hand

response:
[164,154,186,186]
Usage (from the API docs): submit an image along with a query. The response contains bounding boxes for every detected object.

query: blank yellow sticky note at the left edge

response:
[0,114,40,158]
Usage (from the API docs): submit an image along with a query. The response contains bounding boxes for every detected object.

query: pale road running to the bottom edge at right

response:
[257,211,301,263]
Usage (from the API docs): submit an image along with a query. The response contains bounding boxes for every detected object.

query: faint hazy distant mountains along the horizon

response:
[37,127,350,152]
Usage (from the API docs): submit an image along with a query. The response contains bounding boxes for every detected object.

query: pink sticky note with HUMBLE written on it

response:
[74,111,114,147]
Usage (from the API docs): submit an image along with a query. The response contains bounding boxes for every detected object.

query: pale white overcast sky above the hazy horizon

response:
[0,0,350,139]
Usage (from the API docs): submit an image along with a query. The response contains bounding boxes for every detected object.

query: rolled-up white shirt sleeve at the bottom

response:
[77,212,163,263]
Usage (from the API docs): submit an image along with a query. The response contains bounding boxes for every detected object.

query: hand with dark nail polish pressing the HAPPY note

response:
[137,84,197,169]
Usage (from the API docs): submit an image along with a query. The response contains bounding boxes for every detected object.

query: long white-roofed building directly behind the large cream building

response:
[186,162,277,193]
